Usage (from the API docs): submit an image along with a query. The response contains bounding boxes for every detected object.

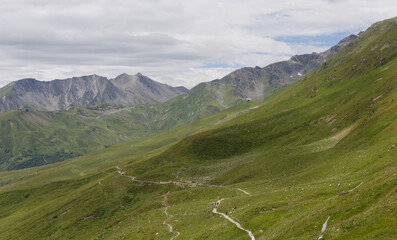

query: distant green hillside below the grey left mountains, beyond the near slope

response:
[0,79,237,171]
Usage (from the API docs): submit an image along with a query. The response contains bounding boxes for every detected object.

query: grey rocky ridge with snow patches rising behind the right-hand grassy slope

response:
[181,35,357,116]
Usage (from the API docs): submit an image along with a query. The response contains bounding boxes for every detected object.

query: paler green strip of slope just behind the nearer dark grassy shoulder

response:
[0,102,260,189]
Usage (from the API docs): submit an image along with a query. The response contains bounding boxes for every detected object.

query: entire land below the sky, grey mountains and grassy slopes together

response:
[0,3,397,240]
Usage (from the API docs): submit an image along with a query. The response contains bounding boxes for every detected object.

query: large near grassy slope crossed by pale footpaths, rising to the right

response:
[0,19,397,239]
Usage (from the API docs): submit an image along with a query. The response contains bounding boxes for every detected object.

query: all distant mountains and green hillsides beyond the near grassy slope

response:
[0,35,355,170]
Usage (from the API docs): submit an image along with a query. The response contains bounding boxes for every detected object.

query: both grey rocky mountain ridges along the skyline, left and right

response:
[0,35,357,112]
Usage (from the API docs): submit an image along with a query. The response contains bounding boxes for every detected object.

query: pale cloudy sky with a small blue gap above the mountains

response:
[0,0,397,88]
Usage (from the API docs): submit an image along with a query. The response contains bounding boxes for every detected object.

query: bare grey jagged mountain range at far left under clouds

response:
[0,73,188,112]
